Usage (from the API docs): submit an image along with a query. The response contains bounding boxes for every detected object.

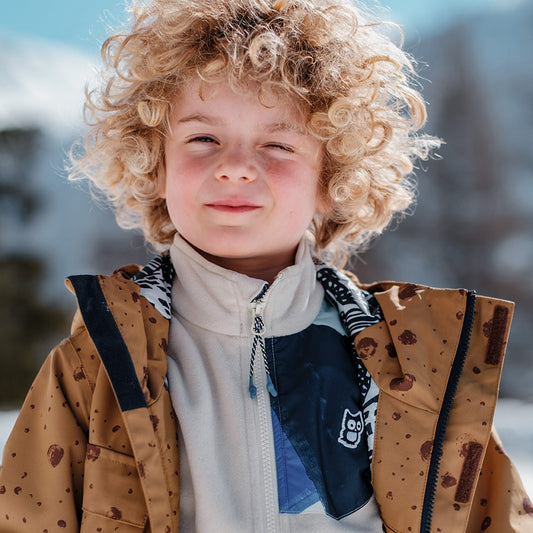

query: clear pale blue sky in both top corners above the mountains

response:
[0,0,532,53]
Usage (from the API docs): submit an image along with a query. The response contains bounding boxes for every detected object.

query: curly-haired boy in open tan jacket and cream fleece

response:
[0,0,533,532]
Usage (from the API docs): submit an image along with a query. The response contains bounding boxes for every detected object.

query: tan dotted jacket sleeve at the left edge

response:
[0,332,91,533]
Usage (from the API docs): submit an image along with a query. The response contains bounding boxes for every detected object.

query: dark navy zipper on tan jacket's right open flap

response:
[420,291,476,533]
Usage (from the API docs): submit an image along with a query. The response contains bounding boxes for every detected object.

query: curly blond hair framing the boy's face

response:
[70,0,438,251]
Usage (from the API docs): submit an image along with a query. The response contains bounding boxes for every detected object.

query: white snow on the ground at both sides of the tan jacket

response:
[0,399,533,497]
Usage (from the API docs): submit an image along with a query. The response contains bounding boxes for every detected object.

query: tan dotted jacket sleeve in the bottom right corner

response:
[467,428,533,533]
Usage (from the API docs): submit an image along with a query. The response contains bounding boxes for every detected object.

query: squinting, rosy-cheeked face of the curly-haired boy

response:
[163,80,322,281]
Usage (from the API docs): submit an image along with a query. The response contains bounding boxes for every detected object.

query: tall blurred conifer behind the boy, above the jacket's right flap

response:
[434,26,504,295]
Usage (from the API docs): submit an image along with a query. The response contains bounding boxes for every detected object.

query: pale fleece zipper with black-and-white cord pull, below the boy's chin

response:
[250,288,277,533]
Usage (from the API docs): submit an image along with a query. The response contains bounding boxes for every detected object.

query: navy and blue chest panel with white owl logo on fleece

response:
[266,325,372,519]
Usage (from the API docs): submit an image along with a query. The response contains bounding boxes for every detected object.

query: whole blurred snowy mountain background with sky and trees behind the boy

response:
[0,0,533,494]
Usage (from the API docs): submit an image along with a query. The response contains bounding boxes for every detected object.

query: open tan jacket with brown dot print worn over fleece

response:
[0,267,533,533]
